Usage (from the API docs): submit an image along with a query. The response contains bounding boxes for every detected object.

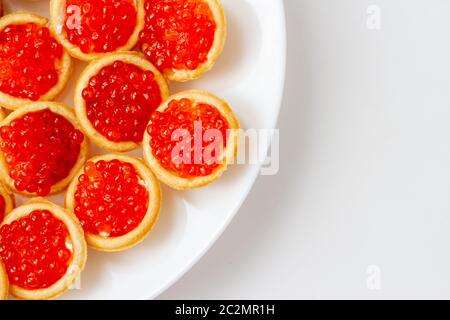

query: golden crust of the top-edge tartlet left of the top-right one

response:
[50,0,145,61]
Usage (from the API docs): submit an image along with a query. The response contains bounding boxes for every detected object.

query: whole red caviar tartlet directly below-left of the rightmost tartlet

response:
[66,154,161,251]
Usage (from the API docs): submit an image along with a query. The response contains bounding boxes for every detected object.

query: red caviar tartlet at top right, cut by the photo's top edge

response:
[139,0,227,81]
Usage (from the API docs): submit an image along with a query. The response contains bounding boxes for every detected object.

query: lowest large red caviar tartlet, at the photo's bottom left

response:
[0,198,87,299]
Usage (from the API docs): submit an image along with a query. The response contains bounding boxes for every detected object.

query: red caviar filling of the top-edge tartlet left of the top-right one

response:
[64,0,137,53]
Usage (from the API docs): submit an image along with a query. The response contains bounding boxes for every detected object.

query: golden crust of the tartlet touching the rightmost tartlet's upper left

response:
[74,51,170,152]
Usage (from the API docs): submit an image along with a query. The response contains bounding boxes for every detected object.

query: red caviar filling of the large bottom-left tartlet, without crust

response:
[0,210,73,290]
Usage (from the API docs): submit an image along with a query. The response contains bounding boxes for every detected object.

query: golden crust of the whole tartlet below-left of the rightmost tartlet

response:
[66,154,162,252]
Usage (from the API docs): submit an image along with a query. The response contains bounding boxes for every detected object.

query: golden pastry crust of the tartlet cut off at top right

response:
[142,0,227,82]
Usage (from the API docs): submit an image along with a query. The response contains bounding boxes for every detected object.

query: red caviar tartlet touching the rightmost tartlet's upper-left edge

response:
[75,52,169,151]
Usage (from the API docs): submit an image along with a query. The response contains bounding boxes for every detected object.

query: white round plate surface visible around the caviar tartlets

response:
[4,0,286,299]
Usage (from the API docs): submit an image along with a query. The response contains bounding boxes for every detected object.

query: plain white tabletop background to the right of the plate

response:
[160,0,450,299]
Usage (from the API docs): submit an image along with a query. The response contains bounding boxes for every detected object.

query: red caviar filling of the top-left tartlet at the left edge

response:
[0,23,64,101]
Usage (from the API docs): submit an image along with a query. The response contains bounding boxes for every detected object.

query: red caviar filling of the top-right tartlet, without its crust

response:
[140,0,217,70]
